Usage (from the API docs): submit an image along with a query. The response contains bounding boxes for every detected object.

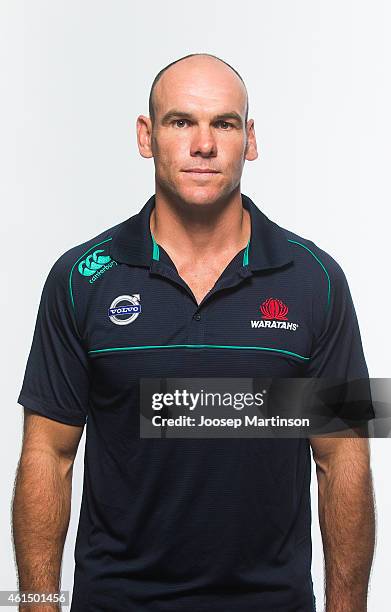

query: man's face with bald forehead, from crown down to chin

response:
[138,58,256,204]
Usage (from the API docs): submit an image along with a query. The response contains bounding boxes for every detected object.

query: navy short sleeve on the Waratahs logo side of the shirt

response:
[306,258,375,424]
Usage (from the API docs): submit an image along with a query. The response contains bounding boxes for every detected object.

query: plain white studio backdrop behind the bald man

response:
[0,0,391,612]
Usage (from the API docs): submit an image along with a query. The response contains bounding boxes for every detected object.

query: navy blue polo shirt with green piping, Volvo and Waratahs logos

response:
[18,194,374,612]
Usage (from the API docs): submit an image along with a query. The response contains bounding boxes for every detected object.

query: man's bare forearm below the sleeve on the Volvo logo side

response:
[12,408,83,612]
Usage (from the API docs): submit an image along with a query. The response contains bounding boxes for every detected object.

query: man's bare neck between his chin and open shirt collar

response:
[150,188,251,264]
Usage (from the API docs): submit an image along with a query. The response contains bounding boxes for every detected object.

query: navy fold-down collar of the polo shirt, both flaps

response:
[109,193,293,270]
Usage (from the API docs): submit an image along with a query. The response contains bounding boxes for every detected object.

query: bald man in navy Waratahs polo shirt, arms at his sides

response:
[13,54,374,612]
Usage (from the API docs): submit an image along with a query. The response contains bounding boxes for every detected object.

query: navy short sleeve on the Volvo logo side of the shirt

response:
[18,255,89,425]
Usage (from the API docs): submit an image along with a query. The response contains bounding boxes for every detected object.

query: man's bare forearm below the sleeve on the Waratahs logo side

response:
[310,434,375,612]
